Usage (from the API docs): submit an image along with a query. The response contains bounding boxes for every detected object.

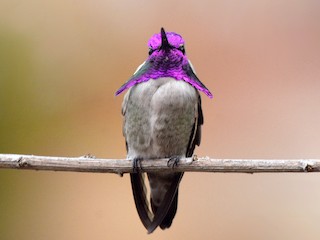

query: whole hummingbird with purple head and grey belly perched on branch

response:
[116,28,212,233]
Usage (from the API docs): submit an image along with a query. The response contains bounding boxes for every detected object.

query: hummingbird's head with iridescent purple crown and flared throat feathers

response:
[116,28,213,98]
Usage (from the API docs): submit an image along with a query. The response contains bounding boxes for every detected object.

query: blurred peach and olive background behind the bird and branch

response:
[0,0,320,240]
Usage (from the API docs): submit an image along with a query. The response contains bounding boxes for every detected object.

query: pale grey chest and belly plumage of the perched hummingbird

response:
[123,78,198,158]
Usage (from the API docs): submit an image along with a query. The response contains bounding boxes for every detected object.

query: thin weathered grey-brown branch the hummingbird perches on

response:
[0,154,320,175]
